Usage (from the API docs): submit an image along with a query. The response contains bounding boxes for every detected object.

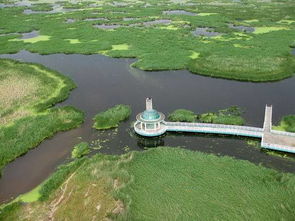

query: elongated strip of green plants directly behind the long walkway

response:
[168,106,245,125]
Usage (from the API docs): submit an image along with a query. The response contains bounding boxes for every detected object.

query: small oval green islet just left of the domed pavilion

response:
[93,104,131,130]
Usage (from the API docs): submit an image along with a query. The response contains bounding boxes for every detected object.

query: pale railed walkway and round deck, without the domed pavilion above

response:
[134,105,295,153]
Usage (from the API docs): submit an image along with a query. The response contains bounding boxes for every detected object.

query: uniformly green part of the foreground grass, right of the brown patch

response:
[120,148,295,220]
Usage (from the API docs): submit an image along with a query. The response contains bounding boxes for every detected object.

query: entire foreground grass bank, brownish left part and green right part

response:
[0,147,295,220]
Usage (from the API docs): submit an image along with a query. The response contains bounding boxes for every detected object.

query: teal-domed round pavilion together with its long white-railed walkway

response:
[134,98,295,153]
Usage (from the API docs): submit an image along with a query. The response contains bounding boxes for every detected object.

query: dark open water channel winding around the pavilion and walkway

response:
[0,51,295,202]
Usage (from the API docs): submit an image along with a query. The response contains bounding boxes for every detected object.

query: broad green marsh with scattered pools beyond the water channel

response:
[0,0,295,82]
